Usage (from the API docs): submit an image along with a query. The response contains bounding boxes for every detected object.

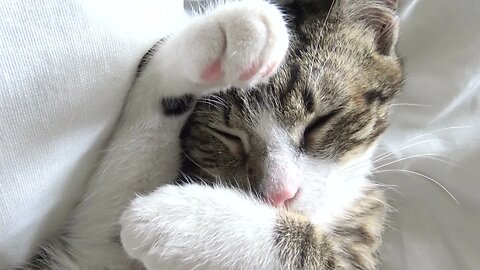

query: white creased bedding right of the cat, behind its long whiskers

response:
[376,0,480,270]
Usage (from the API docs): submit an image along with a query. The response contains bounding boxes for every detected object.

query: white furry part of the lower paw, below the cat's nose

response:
[120,184,275,269]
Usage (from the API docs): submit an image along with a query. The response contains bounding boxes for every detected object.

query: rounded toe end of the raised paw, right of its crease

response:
[223,2,288,87]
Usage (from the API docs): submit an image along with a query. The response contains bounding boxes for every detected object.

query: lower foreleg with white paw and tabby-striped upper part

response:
[121,184,383,270]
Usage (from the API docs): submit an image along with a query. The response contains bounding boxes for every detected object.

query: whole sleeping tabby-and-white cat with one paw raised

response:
[28,0,403,270]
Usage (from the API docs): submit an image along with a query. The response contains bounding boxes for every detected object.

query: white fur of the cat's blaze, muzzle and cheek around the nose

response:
[251,112,374,229]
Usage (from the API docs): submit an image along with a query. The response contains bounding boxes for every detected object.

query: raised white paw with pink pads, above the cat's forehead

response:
[178,0,288,87]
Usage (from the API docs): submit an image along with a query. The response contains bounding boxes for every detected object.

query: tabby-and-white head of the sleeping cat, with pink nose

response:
[181,0,403,221]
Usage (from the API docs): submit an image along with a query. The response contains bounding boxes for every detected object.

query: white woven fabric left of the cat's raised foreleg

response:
[0,0,183,268]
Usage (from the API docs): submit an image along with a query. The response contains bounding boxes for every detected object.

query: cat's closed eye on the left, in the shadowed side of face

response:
[207,125,248,159]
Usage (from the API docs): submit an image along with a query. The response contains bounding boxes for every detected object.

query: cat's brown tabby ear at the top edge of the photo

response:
[337,0,399,55]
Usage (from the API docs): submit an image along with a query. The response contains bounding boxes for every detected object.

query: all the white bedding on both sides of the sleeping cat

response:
[0,0,480,269]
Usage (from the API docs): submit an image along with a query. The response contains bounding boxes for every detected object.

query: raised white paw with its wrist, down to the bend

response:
[137,0,288,100]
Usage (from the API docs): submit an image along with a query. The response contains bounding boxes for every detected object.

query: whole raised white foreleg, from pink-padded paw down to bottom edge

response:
[47,0,288,270]
